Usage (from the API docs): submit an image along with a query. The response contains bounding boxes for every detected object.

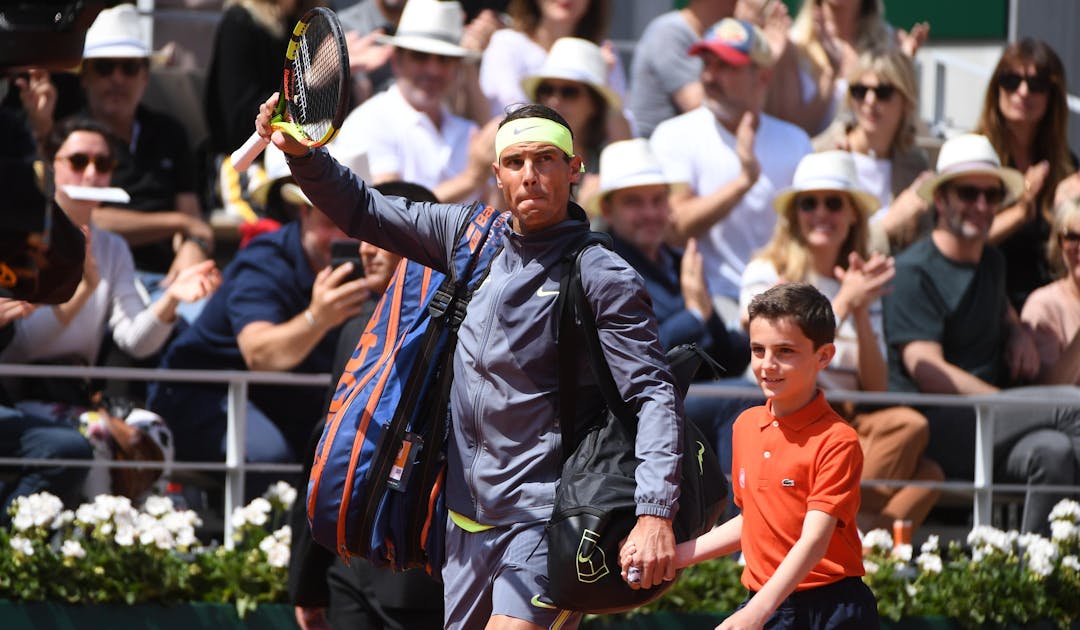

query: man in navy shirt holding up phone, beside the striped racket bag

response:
[148,184,370,461]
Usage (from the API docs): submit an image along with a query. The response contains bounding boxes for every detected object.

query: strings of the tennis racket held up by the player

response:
[288,17,342,139]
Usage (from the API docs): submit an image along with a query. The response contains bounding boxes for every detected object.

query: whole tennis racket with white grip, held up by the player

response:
[231,6,349,171]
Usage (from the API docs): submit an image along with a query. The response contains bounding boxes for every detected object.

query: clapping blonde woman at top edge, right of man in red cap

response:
[766,0,930,135]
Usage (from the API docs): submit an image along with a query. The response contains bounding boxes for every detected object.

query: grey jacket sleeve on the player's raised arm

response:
[288,149,472,272]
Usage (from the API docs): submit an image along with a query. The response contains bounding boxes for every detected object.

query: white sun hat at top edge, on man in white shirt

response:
[377,0,478,57]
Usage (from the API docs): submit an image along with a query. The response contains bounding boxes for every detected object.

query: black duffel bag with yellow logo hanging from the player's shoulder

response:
[546,234,728,614]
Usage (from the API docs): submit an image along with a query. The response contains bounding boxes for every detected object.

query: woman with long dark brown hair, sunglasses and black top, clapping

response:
[975,38,1080,310]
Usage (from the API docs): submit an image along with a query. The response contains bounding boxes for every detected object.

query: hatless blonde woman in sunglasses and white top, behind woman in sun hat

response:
[813,50,933,254]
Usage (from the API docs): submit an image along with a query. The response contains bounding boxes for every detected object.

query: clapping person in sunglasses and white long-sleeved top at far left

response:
[0,119,221,389]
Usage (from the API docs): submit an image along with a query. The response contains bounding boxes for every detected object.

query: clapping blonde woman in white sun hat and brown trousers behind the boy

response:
[740,151,944,531]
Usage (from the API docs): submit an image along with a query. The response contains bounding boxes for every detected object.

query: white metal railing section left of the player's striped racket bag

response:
[0,364,330,547]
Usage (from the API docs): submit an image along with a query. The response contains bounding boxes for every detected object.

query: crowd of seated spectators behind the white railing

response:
[0,0,1080,627]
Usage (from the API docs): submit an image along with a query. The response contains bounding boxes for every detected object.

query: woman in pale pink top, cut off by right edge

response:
[1021,198,1080,386]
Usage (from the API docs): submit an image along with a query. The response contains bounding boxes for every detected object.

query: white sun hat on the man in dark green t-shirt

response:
[919,133,1024,207]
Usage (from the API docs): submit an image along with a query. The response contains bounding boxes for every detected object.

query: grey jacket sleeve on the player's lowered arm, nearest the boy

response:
[582,247,684,518]
